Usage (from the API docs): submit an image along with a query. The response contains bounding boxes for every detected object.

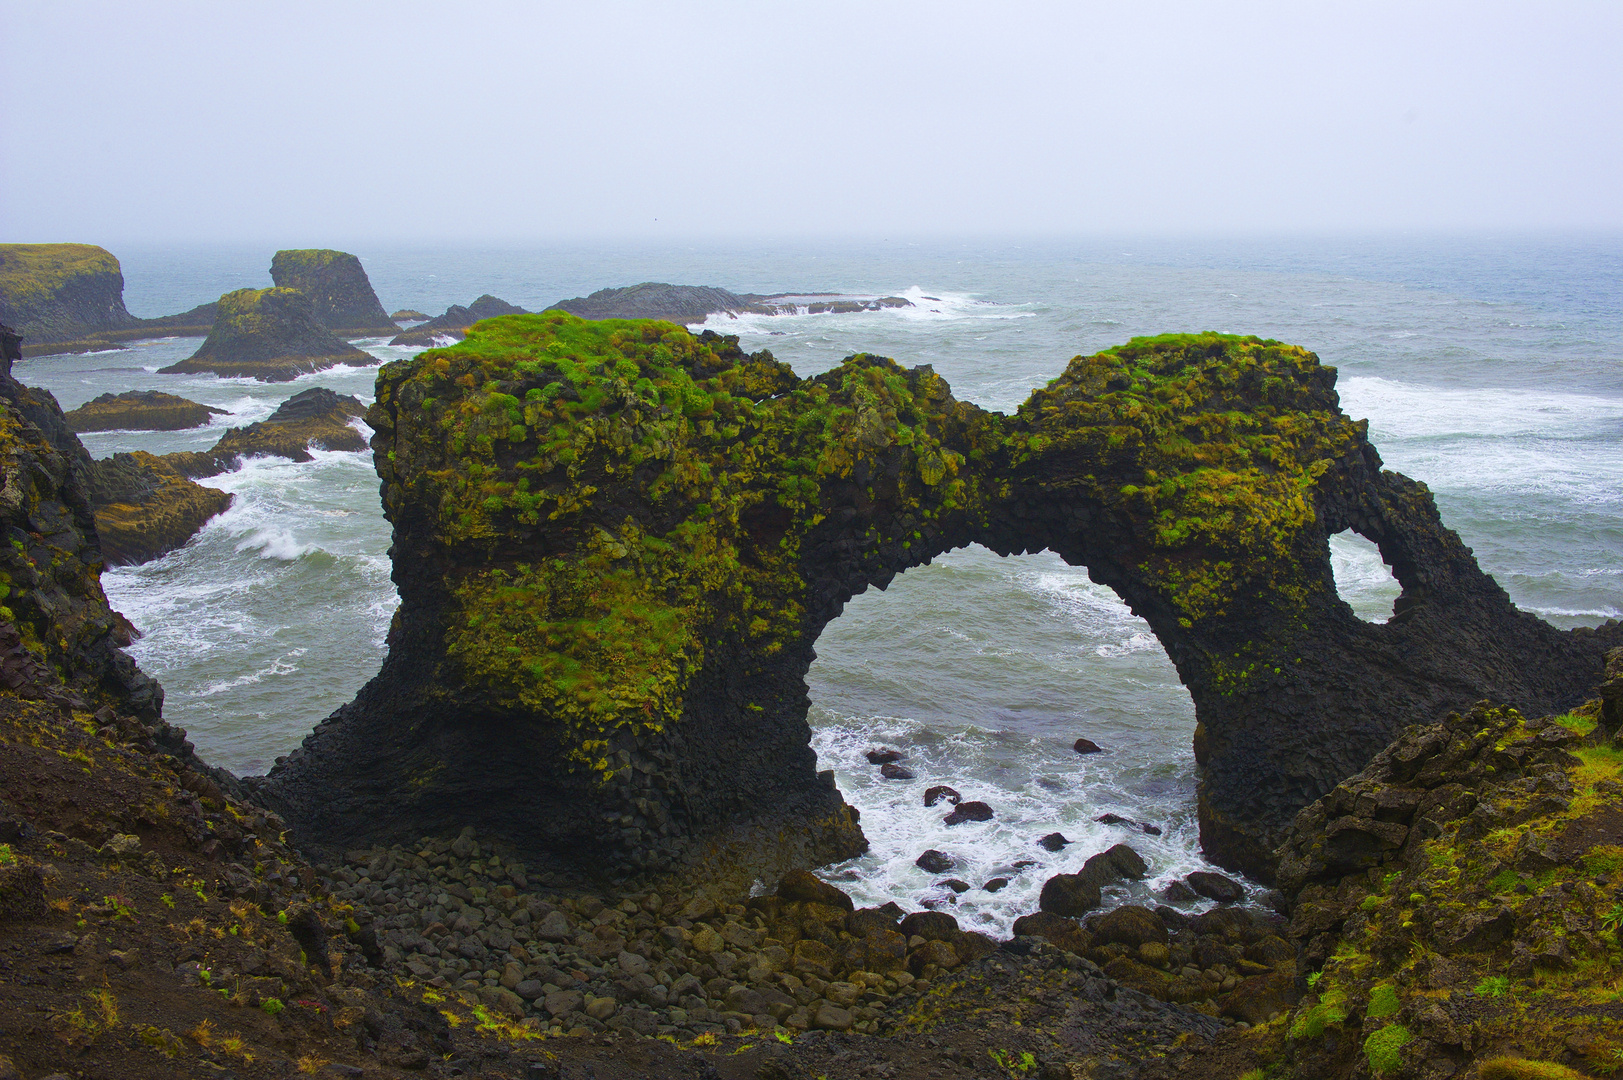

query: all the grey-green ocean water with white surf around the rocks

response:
[16,237,1623,934]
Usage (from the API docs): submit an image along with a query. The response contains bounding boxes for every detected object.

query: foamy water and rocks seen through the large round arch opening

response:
[807,544,1233,937]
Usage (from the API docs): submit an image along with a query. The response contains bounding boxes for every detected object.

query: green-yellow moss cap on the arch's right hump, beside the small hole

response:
[1011,333,1365,626]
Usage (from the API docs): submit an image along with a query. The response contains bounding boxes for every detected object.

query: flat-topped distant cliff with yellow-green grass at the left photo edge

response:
[0,244,140,356]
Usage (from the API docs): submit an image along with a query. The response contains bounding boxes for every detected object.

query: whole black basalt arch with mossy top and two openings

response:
[256,312,1620,882]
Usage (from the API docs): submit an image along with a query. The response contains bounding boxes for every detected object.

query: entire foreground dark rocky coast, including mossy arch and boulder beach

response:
[0,256,1623,1080]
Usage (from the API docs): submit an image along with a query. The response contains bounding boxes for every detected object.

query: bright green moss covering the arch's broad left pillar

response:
[368,312,1000,778]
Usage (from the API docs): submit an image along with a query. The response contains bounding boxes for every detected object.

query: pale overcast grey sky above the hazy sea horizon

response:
[0,0,1623,244]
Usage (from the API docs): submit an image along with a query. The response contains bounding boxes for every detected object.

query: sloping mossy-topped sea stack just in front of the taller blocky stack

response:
[162,287,377,383]
